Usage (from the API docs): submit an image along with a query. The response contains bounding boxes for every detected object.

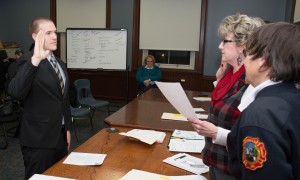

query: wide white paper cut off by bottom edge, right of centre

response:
[119,169,207,180]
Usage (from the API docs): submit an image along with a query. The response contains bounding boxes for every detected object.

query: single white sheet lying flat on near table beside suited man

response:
[63,152,106,166]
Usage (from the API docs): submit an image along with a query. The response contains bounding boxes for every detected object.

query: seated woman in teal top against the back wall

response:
[135,55,161,95]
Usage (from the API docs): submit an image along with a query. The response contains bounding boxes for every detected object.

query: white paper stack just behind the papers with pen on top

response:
[168,129,205,153]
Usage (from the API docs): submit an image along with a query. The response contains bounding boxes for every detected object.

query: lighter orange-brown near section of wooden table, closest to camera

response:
[43,127,209,180]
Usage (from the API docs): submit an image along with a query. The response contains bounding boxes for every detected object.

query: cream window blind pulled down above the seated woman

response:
[139,0,201,51]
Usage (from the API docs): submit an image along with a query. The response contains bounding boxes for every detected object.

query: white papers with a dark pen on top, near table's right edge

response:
[163,153,209,174]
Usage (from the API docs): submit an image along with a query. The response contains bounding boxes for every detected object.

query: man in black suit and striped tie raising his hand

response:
[8,18,71,179]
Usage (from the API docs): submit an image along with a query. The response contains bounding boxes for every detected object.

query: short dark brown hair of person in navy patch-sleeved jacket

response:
[246,22,300,82]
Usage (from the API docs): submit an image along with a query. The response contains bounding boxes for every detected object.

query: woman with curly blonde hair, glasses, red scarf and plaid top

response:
[188,14,264,180]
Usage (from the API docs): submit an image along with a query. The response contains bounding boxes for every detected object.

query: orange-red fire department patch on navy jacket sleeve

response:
[243,136,267,171]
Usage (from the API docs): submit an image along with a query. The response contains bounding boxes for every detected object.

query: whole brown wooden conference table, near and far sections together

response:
[43,88,209,180]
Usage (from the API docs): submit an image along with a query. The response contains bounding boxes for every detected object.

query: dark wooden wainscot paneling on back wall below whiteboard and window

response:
[68,70,215,102]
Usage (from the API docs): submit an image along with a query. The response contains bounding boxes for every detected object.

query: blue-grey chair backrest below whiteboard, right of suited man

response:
[74,79,93,100]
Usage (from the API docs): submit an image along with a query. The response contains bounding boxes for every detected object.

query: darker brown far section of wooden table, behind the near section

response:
[105,88,210,131]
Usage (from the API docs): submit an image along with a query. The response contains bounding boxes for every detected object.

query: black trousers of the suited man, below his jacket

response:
[21,127,68,179]
